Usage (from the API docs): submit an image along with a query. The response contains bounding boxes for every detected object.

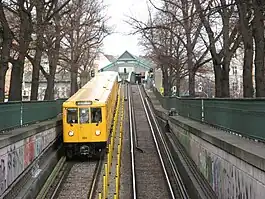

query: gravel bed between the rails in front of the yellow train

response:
[57,160,97,199]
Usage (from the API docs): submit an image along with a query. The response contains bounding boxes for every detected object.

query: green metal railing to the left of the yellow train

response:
[0,99,66,132]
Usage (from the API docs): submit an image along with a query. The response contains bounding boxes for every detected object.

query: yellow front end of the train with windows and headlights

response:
[63,101,107,159]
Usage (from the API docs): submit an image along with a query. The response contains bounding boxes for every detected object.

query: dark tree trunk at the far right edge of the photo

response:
[253,1,265,97]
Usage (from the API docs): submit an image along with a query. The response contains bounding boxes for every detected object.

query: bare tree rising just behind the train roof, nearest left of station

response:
[61,0,109,94]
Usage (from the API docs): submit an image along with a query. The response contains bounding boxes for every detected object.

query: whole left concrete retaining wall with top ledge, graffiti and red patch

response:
[0,119,62,196]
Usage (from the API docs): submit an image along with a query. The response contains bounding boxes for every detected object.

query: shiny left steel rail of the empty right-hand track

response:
[128,83,137,199]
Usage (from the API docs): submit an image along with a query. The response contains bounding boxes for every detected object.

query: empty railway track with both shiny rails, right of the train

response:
[128,85,189,199]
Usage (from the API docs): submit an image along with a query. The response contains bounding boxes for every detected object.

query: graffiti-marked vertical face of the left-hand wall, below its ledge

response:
[0,128,56,196]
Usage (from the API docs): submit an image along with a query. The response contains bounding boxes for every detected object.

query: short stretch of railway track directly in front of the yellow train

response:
[37,153,104,199]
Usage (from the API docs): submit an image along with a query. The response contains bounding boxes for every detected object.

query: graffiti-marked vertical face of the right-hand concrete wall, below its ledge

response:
[172,123,265,199]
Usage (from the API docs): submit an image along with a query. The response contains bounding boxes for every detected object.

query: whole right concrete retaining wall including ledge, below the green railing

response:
[145,92,265,199]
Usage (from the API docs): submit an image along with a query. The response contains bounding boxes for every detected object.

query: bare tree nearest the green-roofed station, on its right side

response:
[128,13,188,95]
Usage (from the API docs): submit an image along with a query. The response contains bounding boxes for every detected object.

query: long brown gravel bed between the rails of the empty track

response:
[132,85,169,199]
